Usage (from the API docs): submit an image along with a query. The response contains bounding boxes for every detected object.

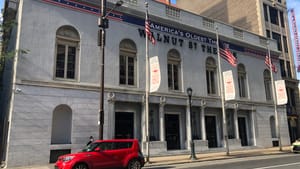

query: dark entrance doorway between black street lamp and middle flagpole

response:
[205,116,218,148]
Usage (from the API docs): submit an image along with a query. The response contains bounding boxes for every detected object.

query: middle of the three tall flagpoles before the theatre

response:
[216,27,229,155]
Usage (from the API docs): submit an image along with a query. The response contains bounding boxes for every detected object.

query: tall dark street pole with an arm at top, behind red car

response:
[98,0,123,140]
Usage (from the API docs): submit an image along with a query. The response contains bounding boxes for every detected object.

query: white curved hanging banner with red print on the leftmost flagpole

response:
[149,56,161,93]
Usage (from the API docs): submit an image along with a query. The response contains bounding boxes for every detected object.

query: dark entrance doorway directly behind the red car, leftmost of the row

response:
[115,112,134,139]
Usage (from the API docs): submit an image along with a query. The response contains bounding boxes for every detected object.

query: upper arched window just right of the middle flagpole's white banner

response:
[237,64,247,98]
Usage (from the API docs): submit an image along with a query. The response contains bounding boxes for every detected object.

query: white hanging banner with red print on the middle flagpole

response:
[223,70,235,100]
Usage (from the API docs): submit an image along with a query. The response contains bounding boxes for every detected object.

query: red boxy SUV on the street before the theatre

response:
[55,139,145,169]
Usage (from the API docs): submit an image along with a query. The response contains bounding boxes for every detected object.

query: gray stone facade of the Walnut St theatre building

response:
[0,0,289,166]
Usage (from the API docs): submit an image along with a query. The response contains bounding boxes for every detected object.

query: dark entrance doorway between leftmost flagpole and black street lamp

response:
[165,114,180,150]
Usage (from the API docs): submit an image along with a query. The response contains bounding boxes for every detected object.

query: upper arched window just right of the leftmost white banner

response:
[168,49,181,90]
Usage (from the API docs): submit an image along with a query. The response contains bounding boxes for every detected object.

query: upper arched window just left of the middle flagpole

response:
[206,57,217,95]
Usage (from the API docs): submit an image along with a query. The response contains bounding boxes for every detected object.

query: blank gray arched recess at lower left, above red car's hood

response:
[51,105,72,144]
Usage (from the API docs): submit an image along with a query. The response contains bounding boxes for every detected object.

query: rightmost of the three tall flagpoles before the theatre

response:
[267,41,282,151]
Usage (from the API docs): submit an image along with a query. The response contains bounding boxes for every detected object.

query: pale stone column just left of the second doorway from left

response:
[159,97,166,141]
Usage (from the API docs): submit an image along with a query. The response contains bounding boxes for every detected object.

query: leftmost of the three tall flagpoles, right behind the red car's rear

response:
[145,2,150,163]
